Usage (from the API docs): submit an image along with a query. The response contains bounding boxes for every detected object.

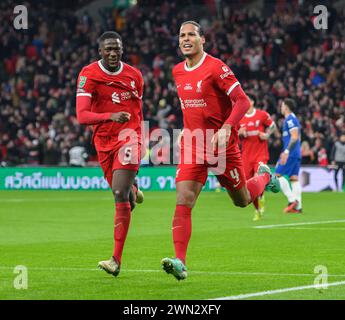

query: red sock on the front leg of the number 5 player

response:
[113,202,131,263]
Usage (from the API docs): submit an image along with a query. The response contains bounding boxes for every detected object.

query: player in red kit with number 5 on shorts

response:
[77,31,144,276]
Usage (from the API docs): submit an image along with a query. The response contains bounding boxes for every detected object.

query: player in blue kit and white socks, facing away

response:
[275,98,302,213]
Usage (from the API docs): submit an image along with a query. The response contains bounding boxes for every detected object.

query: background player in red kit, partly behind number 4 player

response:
[238,94,276,221]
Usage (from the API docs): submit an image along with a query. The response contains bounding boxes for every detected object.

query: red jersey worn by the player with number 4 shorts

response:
[173,52,239,157]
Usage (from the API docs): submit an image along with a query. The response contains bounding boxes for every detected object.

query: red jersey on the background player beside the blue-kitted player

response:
[240,109,273,163]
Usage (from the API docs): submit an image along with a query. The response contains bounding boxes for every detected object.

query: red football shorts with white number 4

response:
[176,148,246,191]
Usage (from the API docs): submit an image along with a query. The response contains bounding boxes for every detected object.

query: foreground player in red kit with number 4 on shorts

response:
[161,21,279,280]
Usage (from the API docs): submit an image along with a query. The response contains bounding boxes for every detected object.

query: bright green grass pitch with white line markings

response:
[0,191,345,300]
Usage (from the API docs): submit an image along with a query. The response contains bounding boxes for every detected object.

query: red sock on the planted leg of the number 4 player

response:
[172,205,192,263]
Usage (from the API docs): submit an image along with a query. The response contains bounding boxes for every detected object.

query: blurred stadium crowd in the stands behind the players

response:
[0,0,345,166]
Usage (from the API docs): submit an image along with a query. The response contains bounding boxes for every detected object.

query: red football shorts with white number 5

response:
[95,144,141,187]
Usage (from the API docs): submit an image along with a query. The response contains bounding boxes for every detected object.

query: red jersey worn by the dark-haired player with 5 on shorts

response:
[77,60,144,151]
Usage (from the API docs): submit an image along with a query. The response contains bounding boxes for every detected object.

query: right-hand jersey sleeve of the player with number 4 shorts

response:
[213,61,240,96]
